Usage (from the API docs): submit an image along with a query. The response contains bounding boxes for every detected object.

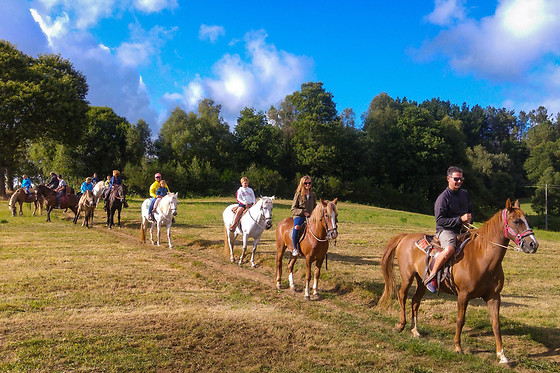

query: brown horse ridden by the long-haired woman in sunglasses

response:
[276,198,338,299]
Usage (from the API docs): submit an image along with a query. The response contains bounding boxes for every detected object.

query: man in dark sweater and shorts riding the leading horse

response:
[424,166,473,293]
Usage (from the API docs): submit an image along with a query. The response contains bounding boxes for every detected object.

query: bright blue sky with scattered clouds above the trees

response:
[0,0,560,135]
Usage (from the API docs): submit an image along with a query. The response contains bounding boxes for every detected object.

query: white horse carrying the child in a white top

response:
[222,196,274,267]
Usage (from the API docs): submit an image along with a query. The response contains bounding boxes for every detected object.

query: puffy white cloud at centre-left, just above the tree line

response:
[164,31,312,126]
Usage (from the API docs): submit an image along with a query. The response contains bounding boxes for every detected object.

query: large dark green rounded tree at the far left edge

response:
[0,41,88,195]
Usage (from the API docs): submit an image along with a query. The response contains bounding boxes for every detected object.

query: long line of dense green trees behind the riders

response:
[0,41,560,227]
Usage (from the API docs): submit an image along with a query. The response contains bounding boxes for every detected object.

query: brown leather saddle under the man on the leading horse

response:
[415,231,471,295]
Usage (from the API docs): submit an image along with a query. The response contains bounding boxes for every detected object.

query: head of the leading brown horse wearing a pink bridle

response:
[502,198,539,253]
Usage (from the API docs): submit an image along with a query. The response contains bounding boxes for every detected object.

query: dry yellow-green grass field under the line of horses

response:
[0,198,560,372]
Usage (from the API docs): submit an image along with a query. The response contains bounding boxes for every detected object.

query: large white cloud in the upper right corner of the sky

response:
[417,0,560,111]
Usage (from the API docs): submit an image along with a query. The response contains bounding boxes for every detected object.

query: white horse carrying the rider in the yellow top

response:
[140,193,179,249]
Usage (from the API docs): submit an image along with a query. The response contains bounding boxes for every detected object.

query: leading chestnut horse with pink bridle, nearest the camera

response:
[379,199,539,364]
